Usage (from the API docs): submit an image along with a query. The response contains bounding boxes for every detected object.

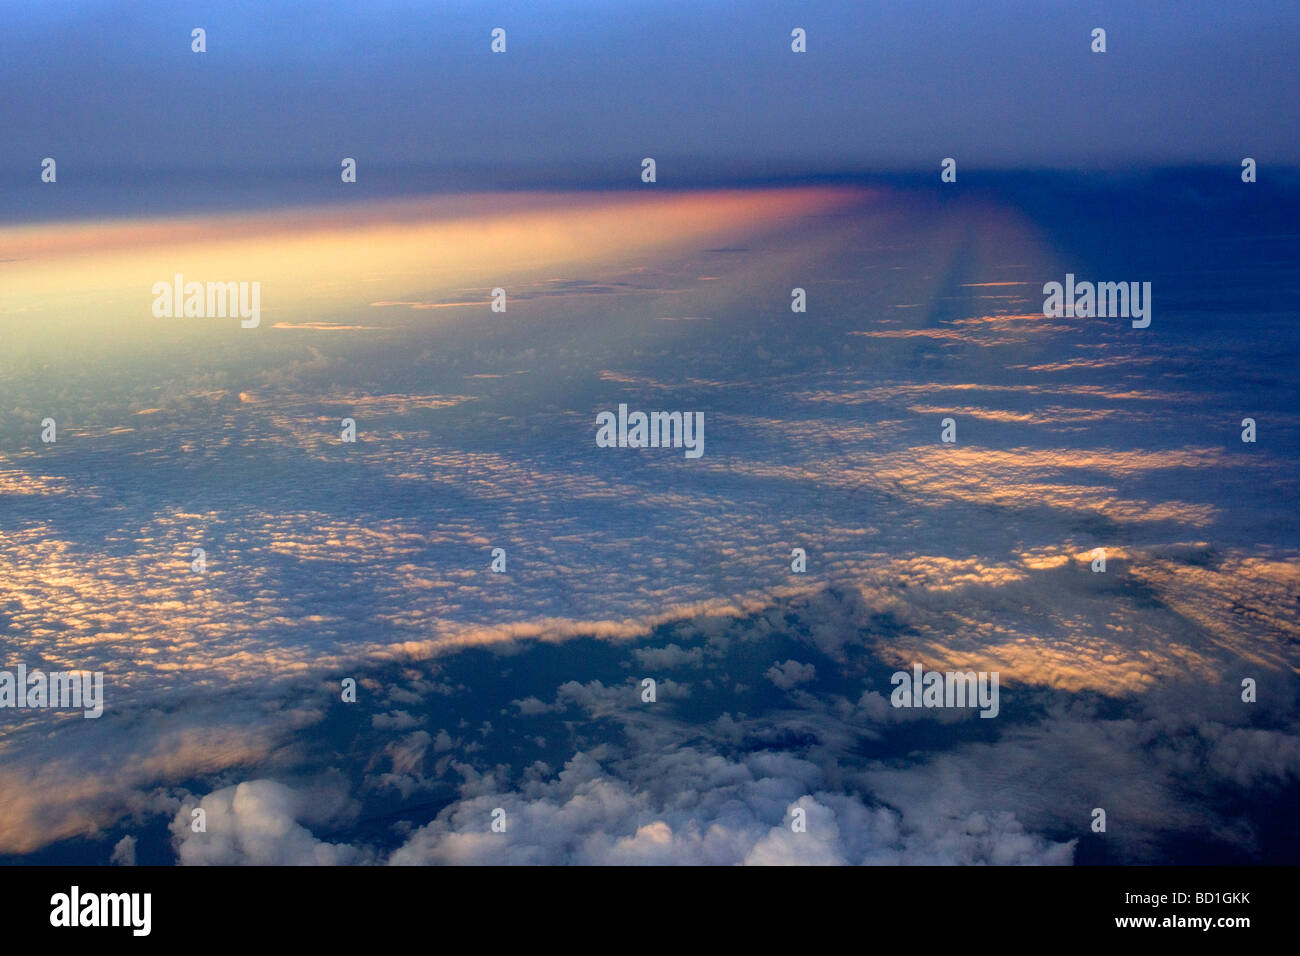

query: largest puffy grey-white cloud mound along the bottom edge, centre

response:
[389,748,1074,865]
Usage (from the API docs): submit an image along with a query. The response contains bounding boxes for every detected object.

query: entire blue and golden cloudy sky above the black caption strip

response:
[0,3,1300,865]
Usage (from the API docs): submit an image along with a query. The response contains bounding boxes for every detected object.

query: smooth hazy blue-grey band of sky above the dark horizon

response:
[0,0,1300,176]
